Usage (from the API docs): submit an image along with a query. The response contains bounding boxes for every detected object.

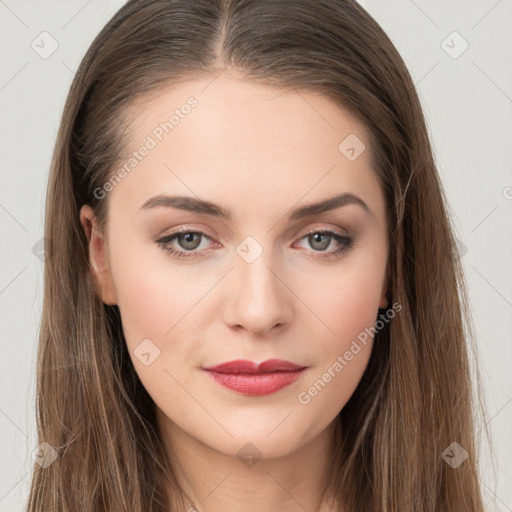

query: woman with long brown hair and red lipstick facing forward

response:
[28,0,483,512]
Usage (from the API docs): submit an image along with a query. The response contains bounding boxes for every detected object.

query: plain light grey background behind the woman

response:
[0,0,512,512]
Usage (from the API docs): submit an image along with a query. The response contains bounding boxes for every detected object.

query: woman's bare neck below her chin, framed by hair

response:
[157,410,335,512]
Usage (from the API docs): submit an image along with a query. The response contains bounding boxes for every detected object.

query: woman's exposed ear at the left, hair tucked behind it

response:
[80,204,117,305]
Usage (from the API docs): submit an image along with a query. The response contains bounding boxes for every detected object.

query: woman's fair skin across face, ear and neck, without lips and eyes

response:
[80,73,388,512]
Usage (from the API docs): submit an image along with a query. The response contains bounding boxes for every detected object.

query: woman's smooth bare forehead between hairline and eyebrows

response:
[106,74,378,220]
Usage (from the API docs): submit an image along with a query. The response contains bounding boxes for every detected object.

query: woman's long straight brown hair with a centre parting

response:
[28,0,483,512]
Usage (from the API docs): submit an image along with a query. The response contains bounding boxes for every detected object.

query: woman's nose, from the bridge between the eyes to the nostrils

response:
[226,237,291,332]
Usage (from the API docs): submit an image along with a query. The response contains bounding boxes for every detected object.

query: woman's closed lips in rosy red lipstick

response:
[203,359,307,396]
